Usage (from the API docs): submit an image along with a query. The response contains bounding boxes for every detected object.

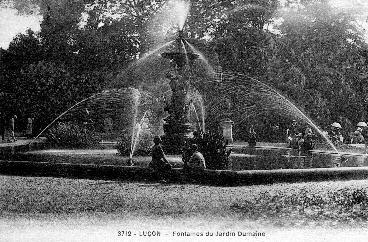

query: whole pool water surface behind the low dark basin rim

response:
[17,145,368,171]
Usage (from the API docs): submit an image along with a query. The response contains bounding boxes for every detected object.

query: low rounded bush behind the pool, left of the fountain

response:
[46,122,99,148]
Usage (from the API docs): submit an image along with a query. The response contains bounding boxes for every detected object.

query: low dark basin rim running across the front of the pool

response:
[0,161,368,186]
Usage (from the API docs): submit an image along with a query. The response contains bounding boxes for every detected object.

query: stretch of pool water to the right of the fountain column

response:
[229,147,368,171]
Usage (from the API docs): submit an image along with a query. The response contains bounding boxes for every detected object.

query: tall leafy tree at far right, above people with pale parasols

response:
[269,1,366,125]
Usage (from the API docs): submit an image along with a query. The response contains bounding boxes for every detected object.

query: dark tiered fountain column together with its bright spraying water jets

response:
[32,1,336,158]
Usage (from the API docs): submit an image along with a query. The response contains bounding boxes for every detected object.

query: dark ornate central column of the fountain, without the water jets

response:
[161,30,199,154]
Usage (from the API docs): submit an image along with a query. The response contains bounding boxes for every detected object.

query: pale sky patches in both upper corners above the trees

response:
[0,0,368,49]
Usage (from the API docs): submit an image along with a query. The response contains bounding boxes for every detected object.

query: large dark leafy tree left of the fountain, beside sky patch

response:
[2,0,144,130]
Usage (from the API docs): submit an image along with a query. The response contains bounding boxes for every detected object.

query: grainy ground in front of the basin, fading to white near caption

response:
[0,176,368,240]
